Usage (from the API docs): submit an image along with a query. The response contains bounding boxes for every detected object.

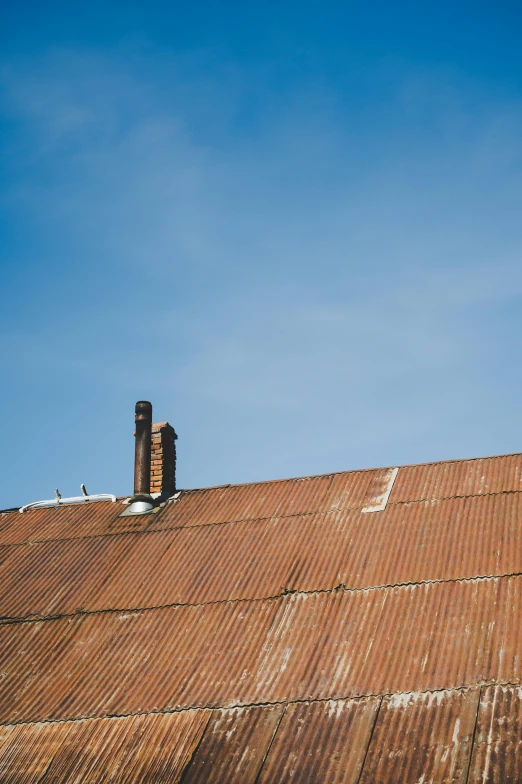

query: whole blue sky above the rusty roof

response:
[0,0,522,507]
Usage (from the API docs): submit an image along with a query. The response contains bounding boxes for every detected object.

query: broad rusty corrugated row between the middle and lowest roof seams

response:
[0,577,522,723]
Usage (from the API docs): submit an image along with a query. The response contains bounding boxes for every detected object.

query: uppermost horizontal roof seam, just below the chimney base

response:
[4,490,522,550]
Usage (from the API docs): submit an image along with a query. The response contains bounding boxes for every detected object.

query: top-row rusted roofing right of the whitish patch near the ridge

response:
[390,454,522,503]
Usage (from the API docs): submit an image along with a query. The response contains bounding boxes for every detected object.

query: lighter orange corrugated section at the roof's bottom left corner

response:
[0,711,210,784]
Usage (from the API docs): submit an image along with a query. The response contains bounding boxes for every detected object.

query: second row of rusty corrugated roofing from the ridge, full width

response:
[4,493,522,617]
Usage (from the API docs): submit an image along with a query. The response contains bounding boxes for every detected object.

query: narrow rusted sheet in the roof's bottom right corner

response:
[469,686,522,784]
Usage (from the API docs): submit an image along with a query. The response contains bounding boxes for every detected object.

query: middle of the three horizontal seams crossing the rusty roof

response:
[0,572,522,626]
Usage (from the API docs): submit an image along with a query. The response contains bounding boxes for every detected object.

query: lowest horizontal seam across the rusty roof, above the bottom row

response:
[0,679,521,727]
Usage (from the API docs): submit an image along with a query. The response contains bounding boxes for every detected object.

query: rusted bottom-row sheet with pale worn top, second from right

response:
[360,689,476,784]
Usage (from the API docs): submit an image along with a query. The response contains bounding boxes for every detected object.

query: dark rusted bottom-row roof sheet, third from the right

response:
[258,698,380,784]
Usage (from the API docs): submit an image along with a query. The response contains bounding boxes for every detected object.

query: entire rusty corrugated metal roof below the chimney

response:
[0,454,522,784]
